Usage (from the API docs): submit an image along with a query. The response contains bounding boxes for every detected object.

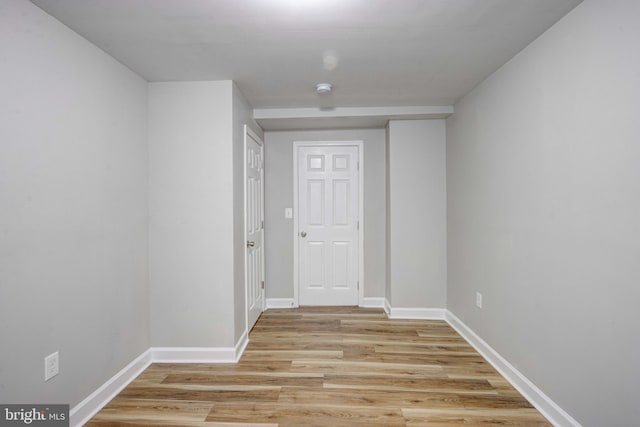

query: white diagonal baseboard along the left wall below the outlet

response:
[69,349,152,426]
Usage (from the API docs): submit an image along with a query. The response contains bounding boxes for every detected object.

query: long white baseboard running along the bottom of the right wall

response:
[445,310,581,427]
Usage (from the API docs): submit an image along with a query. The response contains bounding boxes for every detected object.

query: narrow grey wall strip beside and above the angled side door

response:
[232,83,263,342]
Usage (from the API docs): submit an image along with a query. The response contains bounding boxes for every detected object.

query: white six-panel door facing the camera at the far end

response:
[297,145,360,305]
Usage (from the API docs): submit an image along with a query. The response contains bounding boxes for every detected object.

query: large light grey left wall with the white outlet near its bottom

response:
[0,0,149,406]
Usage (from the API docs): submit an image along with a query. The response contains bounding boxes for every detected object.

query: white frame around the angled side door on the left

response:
[242,124,267,334]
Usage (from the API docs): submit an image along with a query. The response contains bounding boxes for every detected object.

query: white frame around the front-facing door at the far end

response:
[293,140,365,307]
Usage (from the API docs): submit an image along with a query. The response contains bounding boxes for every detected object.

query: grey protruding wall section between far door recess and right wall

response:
[386,120,447,308]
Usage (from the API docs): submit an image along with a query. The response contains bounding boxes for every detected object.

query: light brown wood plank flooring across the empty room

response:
[87,307,551,427]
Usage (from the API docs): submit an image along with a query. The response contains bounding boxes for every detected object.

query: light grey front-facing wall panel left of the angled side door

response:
[149,81,235,347]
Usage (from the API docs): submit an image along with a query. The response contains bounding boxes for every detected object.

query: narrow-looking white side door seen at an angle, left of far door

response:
[245,126,264,330]
